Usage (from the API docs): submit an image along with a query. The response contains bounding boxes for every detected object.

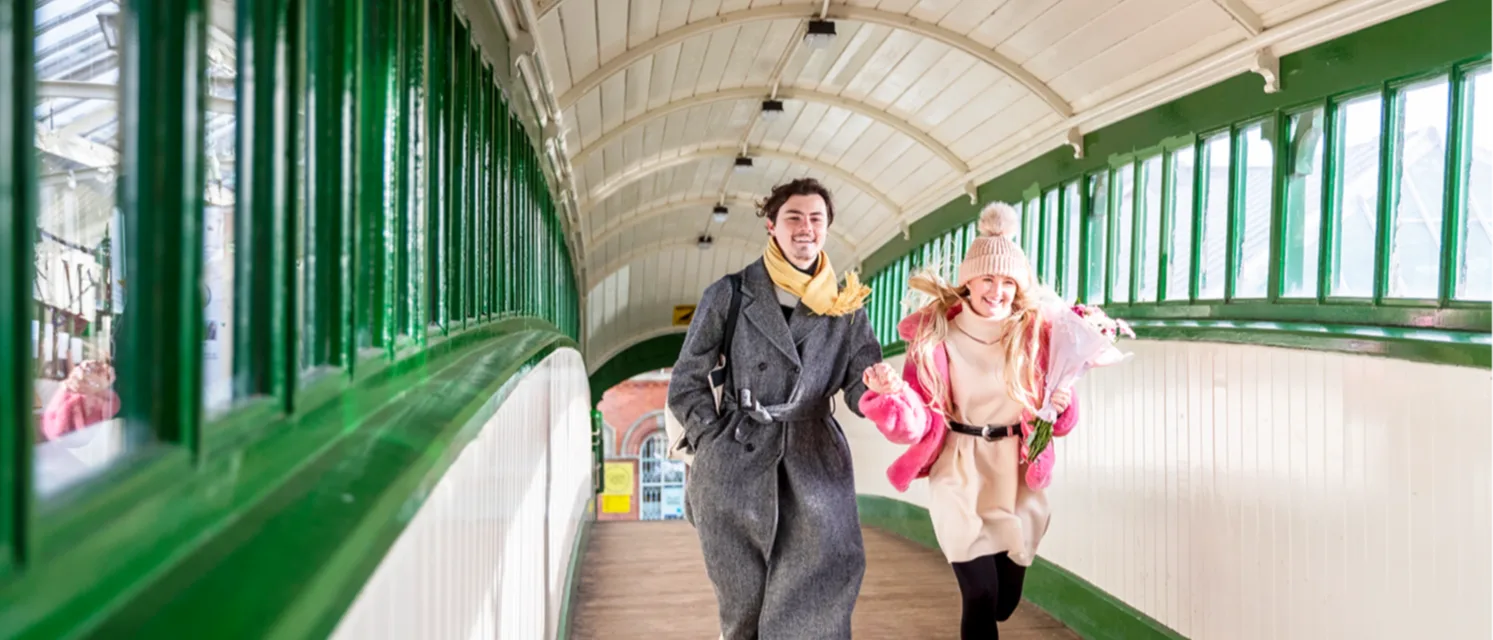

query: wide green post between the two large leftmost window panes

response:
[119,0,208,446]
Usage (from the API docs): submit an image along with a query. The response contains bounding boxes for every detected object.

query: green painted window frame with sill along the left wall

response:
[0,0,579,637]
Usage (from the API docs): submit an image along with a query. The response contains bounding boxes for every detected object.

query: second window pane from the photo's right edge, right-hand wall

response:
[1388,78,1451,298]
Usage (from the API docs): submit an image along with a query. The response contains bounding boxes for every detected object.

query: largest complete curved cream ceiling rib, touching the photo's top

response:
[560,4,1073,118]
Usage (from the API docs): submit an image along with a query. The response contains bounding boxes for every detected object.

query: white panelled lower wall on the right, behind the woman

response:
[838,340,1493,640]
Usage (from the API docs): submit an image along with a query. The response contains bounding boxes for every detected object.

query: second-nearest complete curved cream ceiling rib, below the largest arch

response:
[572,87,969,173]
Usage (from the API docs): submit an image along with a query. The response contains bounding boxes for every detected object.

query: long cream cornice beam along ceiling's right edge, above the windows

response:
[858,0,1442,260]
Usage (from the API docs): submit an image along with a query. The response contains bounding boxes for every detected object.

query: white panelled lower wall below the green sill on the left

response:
[333,351,591,640]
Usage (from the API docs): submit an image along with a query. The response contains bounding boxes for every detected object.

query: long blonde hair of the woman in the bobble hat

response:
[908,269,1047,416]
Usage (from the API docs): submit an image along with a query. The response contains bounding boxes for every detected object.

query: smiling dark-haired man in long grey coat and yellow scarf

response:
[669,179,881,640]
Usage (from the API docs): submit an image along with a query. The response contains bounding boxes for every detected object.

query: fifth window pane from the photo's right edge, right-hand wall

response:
[1233,124,1275,298]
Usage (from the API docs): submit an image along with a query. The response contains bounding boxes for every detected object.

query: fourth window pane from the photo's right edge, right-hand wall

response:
[1281,107,1326,298]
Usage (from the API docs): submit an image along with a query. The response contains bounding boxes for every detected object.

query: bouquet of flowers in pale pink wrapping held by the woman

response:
[1027,304,1135,459]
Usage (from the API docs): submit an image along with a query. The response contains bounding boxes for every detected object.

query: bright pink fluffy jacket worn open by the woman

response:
[860,306,1078,491]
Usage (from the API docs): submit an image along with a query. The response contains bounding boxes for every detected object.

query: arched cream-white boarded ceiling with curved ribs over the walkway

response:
[493,0,1436,364]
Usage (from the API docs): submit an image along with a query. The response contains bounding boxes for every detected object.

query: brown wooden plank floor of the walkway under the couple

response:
[572,521,1078,640]
